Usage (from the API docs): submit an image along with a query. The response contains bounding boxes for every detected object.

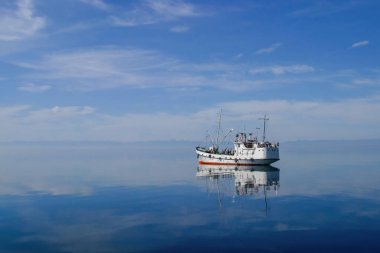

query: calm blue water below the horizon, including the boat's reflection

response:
[0,141,380,252]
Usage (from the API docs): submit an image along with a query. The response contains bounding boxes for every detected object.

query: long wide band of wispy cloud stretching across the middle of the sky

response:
[13,47,379,92]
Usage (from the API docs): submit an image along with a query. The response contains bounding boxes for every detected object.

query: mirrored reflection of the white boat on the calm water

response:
[196,165,280,213]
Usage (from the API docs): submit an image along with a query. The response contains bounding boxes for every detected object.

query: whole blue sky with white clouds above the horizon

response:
[0,0,380,141]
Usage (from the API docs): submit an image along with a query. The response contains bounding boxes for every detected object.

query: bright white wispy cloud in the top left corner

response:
[0,0,45,41]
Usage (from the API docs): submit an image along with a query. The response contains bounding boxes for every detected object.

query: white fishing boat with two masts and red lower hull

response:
[196,112,280,167]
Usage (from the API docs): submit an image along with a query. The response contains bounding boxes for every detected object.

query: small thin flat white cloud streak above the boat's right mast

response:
[250,65,315,75]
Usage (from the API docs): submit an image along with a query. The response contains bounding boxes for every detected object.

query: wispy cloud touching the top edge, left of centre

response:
[111,0,202,26]
